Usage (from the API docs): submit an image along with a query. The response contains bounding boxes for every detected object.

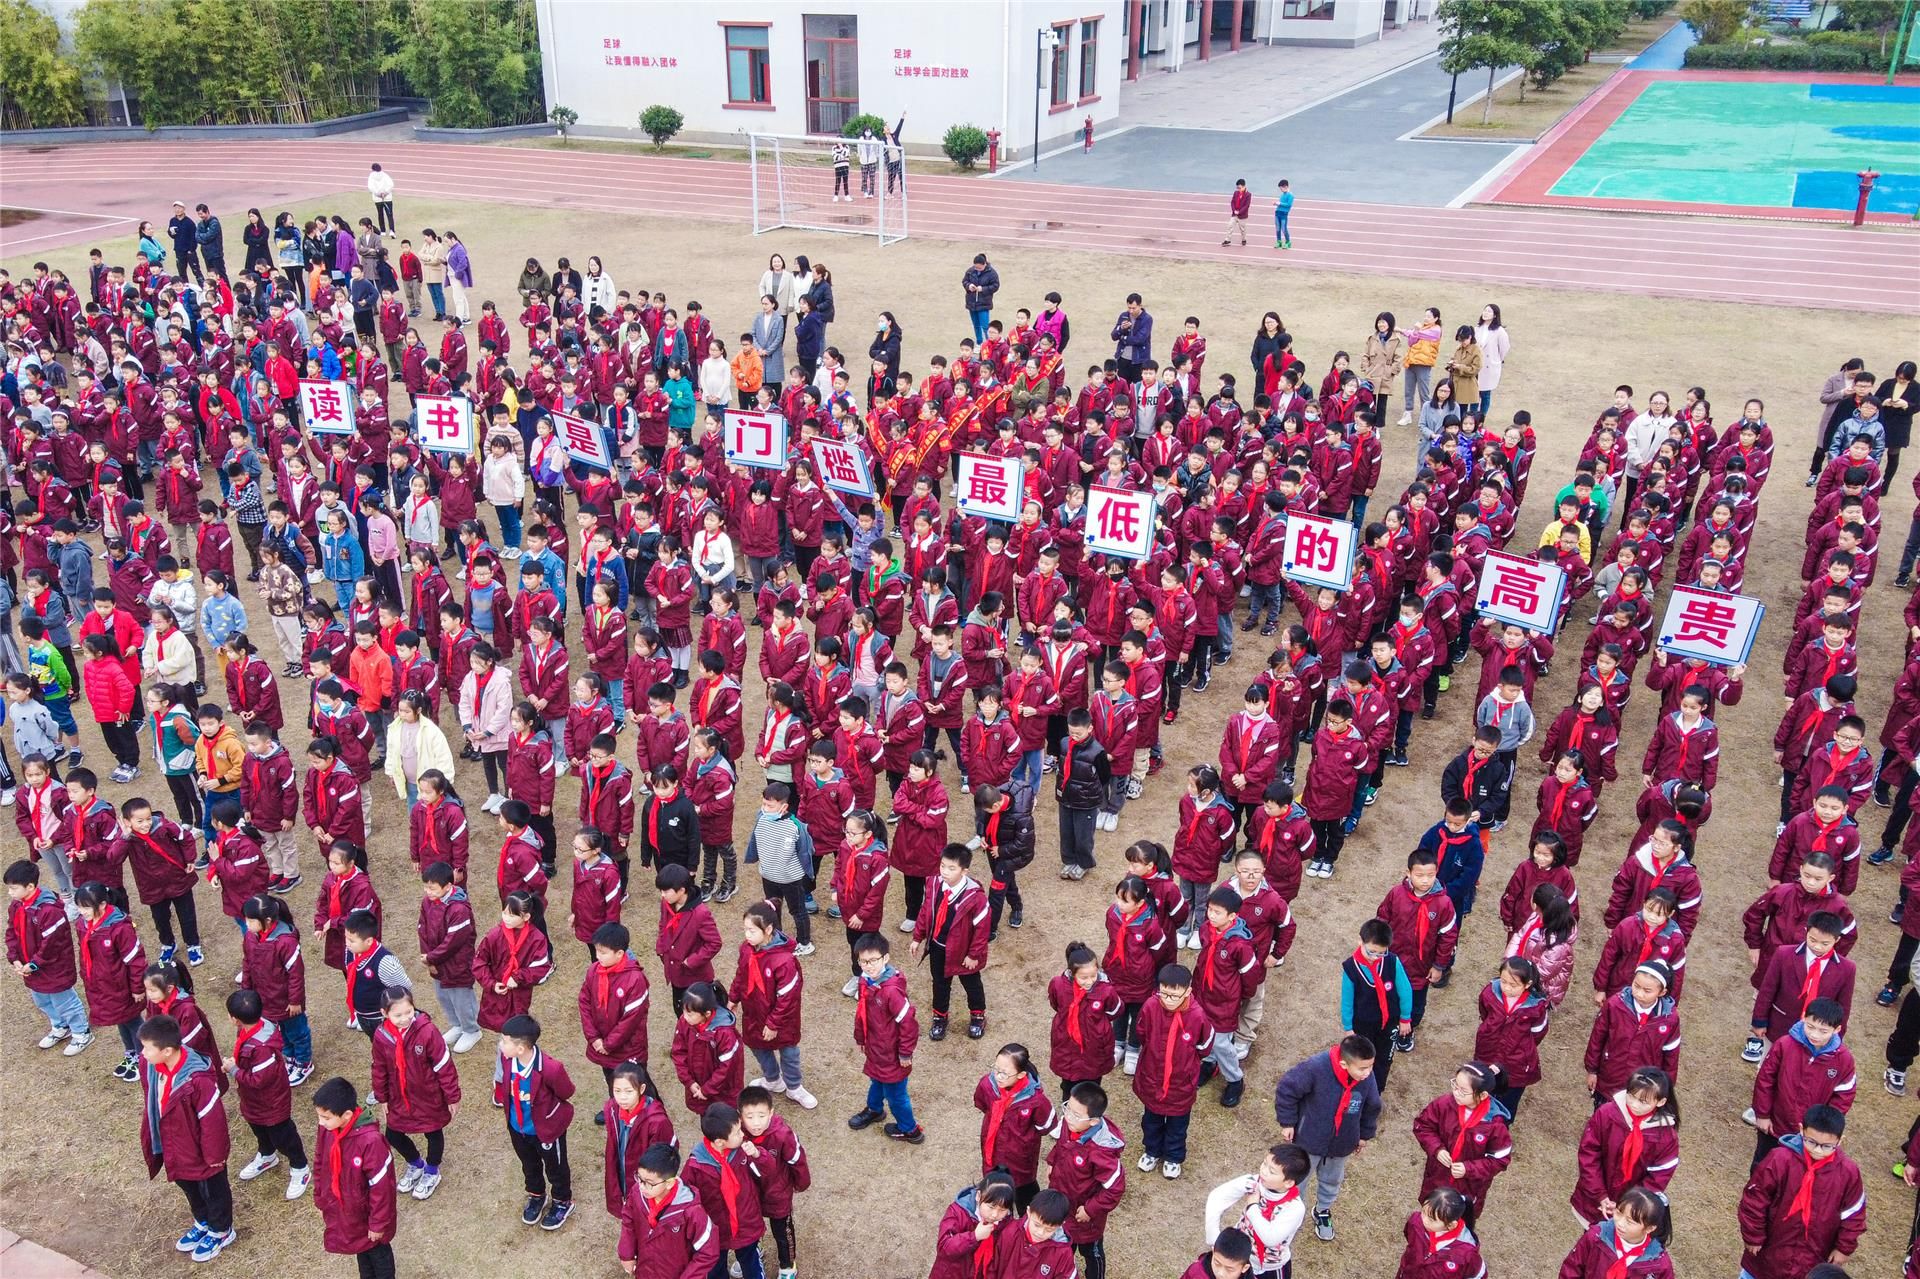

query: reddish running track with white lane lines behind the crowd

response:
[0,140,1920,313]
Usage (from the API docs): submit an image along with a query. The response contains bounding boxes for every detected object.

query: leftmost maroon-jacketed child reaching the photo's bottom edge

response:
[313,1075,399,1279]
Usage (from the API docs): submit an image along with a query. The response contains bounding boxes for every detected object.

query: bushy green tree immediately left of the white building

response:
[382,0,545,129]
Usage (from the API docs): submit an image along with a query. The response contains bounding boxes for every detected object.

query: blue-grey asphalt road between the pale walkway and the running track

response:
[1002,50,1517,207]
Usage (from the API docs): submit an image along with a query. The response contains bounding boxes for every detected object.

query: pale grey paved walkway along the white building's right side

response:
[1096,21,1440,128]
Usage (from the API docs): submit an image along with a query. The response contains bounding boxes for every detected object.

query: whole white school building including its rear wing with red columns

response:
[536,0,1432,157]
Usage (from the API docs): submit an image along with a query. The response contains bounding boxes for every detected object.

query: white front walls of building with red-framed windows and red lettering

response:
[538,0,1125,156]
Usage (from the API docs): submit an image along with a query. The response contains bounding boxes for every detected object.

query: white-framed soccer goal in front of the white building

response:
[747,133,906,244]
